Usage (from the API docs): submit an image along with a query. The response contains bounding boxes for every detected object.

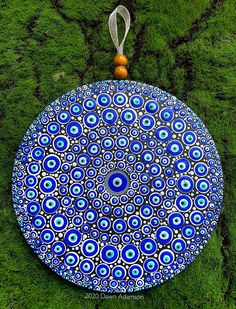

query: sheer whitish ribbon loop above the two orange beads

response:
[108,5,130,55]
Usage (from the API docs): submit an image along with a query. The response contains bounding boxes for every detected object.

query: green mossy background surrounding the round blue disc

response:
[0,0,236,309]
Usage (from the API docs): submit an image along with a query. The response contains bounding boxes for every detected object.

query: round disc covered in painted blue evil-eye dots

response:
[12,80,223,292]
